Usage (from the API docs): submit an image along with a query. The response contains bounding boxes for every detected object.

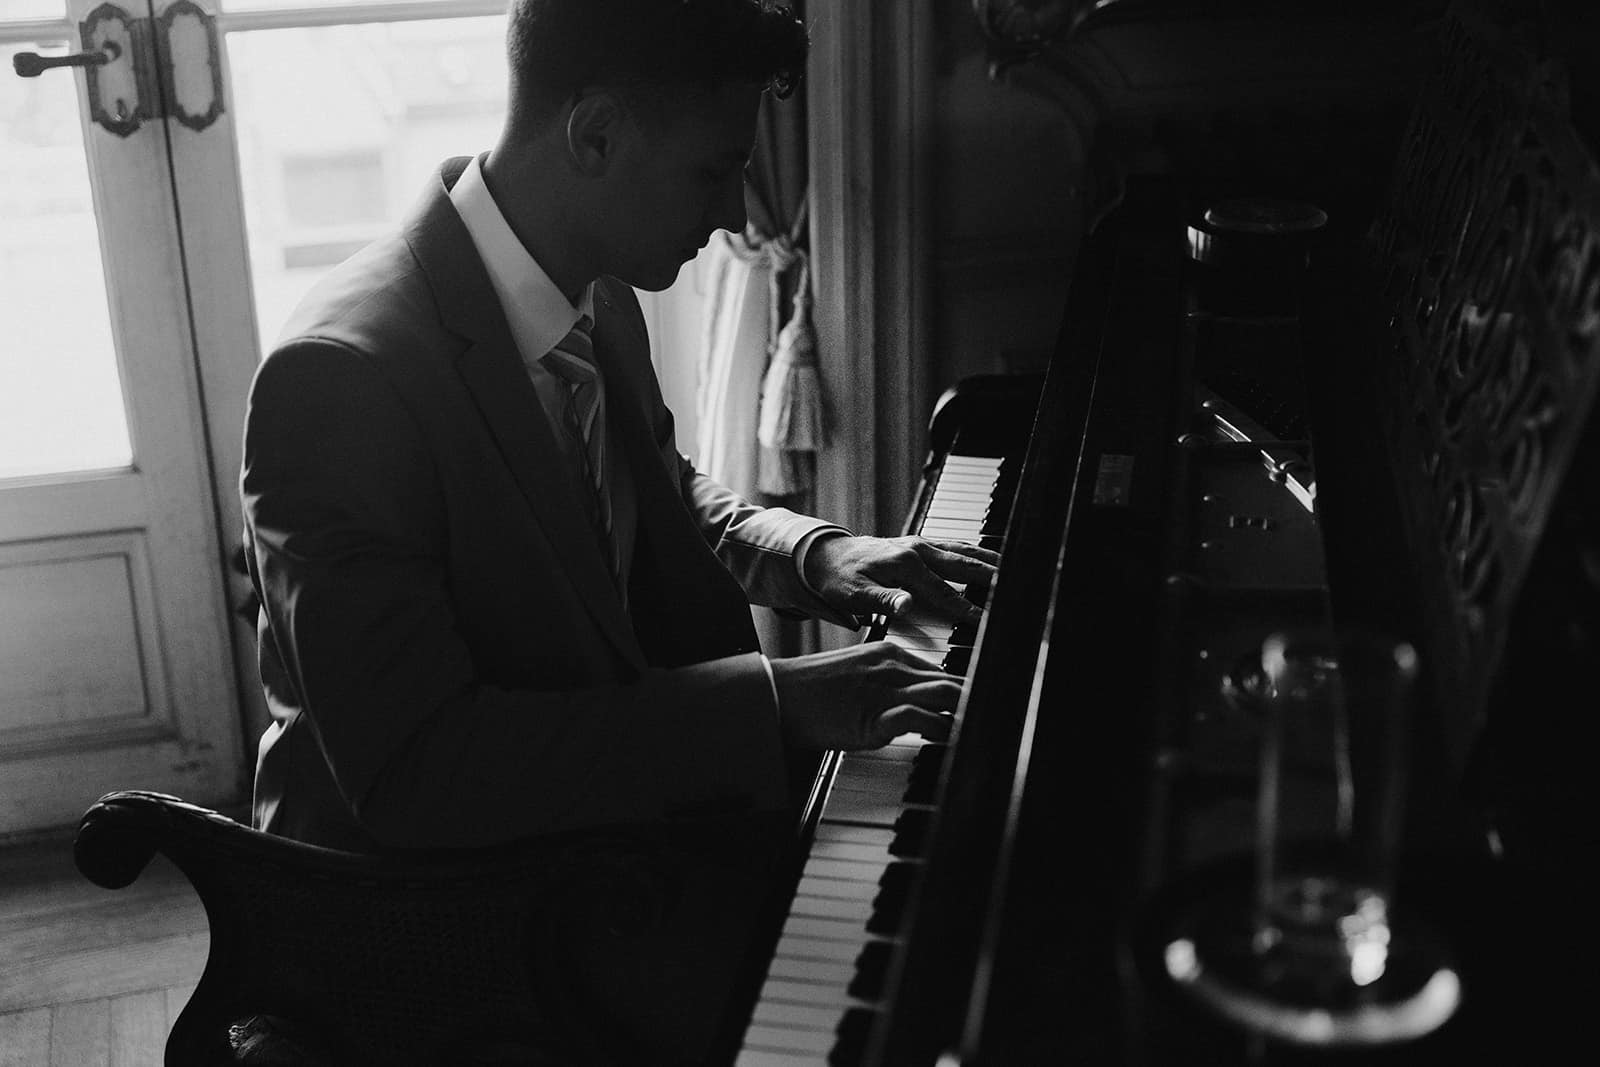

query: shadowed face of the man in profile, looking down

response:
[605,85,762,291]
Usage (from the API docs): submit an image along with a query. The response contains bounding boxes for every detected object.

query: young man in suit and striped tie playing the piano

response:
[242,0,995,1059]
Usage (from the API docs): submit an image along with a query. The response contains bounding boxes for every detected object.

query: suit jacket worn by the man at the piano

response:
[240,158,848,851]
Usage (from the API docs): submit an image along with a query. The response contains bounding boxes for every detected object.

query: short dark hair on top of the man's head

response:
[506,0,808,127]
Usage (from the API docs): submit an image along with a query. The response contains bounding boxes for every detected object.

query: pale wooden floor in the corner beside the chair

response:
[0,840,208,1067]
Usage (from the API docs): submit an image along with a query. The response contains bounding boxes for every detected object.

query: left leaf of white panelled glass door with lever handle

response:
[0,0,248,835]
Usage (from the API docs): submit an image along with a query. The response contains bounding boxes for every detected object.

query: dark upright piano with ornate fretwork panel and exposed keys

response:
[730,5,1600,1067]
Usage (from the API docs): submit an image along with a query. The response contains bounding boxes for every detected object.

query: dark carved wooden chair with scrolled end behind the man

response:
[74,790,688,1067]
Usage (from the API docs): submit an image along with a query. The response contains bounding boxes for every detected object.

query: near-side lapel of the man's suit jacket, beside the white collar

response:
[406,158,645,667]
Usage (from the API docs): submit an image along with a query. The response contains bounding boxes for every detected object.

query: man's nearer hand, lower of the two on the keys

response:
[771,641,962,749]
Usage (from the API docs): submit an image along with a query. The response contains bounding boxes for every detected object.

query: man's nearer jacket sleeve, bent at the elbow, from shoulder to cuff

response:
[242,341,786,846]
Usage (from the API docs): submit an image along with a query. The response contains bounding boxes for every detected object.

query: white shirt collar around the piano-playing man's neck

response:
[450,157,595,362]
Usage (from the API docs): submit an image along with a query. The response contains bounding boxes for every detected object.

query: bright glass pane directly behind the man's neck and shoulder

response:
[227,16,506,350]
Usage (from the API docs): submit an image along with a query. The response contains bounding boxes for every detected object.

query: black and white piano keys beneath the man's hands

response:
[734,446,1021,1067]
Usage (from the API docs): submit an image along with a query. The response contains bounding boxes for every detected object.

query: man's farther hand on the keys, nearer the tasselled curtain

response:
[805,536,1000,622]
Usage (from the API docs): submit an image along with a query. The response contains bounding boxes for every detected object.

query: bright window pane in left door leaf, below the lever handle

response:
[0,45,133,478]
